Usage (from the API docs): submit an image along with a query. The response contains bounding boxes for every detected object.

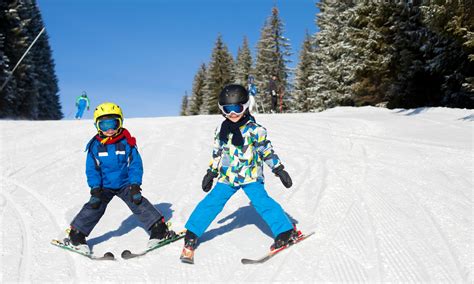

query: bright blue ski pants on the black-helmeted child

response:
[185,182,293,238]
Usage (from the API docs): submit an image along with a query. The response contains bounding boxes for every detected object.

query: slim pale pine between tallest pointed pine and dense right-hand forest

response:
[293,31,316,112]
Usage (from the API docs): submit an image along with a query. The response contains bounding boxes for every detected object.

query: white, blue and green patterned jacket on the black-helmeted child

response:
[209,120,281,186]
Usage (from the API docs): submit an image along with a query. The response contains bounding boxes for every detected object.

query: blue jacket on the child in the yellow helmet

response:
[86,137,143,190]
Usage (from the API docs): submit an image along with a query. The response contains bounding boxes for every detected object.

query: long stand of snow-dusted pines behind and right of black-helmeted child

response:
[181,0,474,115]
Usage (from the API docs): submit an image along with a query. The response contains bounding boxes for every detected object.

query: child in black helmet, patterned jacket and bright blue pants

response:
[181,85,298,263]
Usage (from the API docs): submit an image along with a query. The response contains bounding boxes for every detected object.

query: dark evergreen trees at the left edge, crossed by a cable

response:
[0,0,63,120]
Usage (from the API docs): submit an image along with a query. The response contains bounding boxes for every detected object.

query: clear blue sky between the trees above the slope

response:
[37,0,318,119]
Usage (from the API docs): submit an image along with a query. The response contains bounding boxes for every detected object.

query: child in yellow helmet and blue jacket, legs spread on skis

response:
[69,103,174,252]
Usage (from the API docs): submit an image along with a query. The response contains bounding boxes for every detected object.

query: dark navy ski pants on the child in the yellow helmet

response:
[71,186,163,236]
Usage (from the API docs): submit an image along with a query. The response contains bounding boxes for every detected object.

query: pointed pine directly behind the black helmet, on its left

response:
[200,34,234,114]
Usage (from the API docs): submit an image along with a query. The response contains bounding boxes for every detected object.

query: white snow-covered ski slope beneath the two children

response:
[0,107,474,282]
